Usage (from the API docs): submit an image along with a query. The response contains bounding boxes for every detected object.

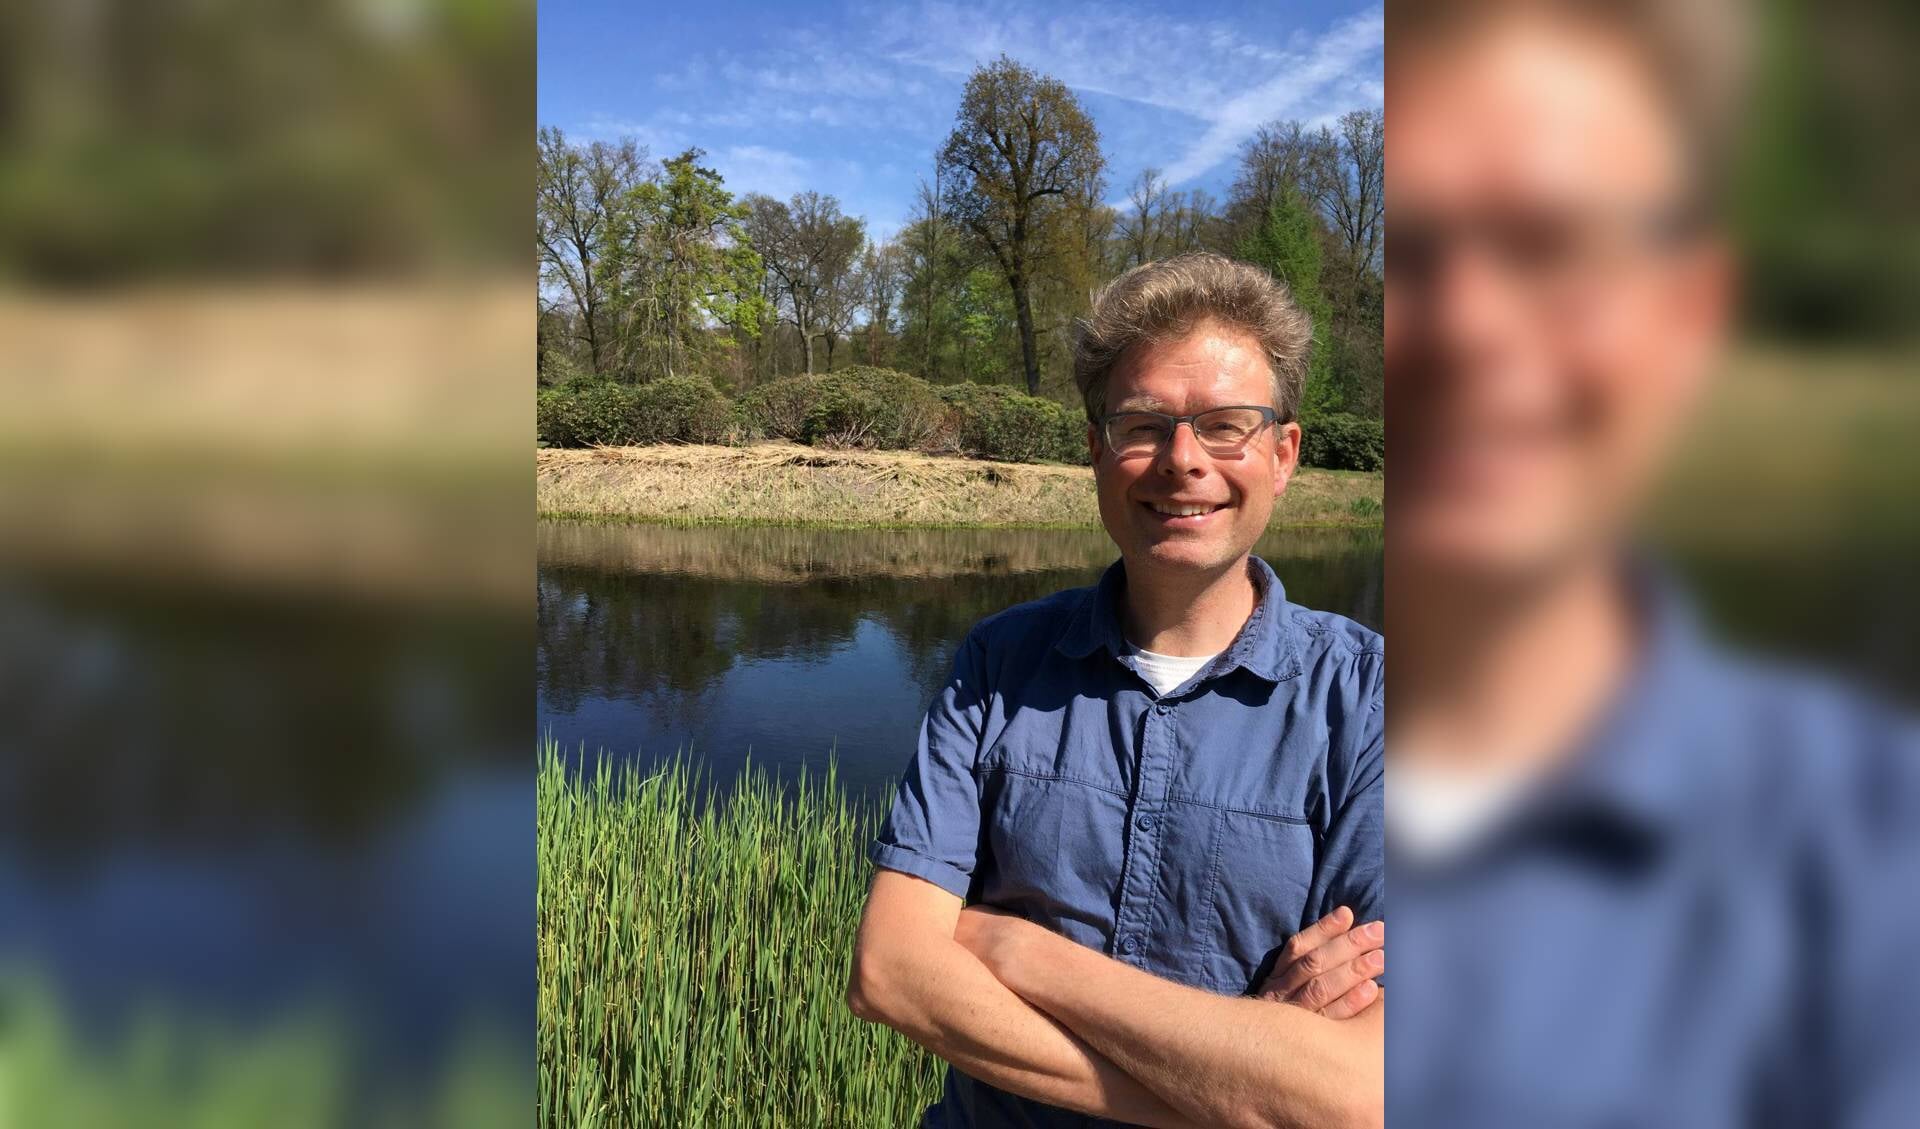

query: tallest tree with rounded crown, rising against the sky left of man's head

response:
[939,56,1106,394]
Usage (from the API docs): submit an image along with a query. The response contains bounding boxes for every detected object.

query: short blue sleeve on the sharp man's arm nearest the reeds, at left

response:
[866,630,987,899]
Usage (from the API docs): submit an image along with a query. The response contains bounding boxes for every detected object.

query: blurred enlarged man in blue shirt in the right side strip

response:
[1386,0,1920,1129]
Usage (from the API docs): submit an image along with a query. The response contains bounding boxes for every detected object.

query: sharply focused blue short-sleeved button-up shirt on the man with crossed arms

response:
[868,557,1384,1127]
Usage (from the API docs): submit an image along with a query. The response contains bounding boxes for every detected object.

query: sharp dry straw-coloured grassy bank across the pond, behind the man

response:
[538,442,1384,528]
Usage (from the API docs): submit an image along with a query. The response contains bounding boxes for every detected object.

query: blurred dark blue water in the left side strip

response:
[0,568,534,1083]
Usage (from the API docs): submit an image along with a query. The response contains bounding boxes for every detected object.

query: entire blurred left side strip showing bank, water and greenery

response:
[0,0,534,1129]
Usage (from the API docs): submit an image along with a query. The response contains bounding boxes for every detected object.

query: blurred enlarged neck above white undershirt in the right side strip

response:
[1386,555,1636,772]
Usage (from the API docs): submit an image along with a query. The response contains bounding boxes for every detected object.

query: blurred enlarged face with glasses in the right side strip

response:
[1386,23,1728,578]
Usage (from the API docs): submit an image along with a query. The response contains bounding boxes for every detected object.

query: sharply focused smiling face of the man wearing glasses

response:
[1089,323,1300,574]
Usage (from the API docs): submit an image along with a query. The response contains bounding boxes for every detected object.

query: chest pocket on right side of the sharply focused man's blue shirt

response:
[1198,808,1313,993]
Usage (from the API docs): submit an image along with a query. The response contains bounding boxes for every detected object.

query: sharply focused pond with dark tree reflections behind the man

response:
[538,522,1382,793]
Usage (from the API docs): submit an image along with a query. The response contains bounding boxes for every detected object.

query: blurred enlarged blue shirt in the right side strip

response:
[1386,570,1920,1129]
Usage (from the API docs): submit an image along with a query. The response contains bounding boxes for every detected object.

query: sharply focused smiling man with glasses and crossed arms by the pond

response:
[849,255,1384,1125]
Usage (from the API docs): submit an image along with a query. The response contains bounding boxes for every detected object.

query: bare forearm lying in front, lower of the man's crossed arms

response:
[996,927,1384,1127]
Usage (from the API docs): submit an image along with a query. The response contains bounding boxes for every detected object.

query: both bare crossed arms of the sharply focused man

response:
[847,870,1386,1127]
